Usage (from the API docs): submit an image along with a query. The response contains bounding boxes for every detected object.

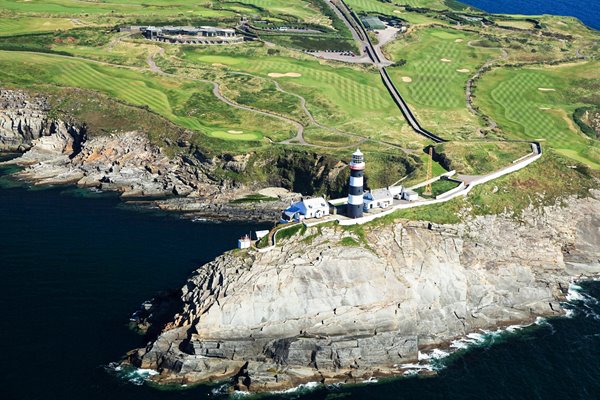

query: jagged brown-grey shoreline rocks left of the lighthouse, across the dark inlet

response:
[0,89,298,221]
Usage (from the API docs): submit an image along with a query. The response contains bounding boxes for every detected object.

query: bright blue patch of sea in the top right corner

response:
[460,0,600,30]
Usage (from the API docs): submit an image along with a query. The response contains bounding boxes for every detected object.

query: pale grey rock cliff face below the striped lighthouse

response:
[132,192,600,390]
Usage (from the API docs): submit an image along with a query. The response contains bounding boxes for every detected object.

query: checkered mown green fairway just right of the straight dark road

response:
[385,27,500,137]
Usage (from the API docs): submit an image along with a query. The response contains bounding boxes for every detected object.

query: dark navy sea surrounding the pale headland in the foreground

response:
[0,152,600,400]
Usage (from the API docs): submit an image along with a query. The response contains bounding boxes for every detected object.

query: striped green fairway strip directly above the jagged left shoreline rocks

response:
[0,51,292,149]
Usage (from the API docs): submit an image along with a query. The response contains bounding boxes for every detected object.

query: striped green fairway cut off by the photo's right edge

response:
[476,61,600,169]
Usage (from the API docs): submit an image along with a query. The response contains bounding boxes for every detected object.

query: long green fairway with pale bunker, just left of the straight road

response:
[183,44,416,142]
